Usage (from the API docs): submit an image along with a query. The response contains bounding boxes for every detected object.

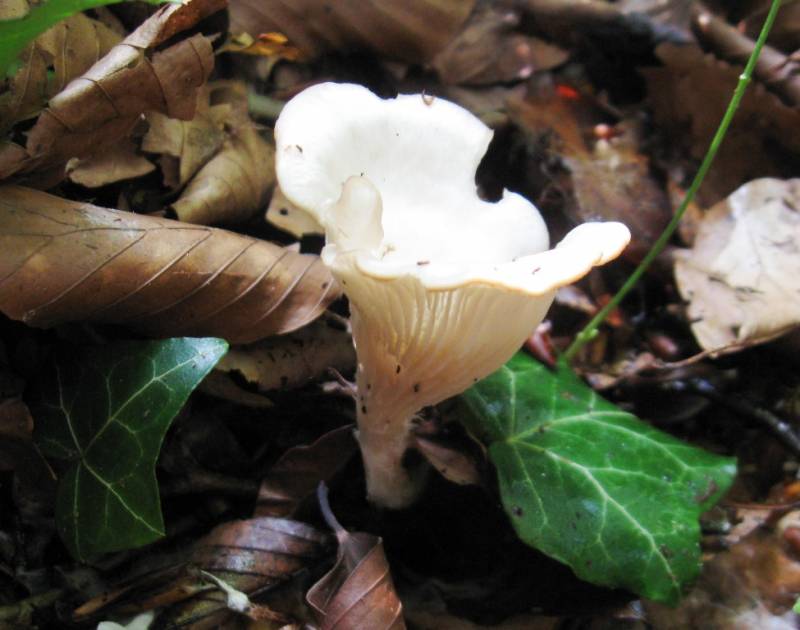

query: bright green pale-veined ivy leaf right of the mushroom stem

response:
[461,354,736,604]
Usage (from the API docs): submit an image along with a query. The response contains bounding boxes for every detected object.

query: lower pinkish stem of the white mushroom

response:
[358,408,425,509]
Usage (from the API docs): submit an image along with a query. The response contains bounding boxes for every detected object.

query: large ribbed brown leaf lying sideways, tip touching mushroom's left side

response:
[0,186,338,343]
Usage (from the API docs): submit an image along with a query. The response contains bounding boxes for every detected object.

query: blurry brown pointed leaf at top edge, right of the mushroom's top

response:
[431,2,569,85]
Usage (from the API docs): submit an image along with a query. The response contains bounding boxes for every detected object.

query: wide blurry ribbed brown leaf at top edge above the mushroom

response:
[230,0,475,62]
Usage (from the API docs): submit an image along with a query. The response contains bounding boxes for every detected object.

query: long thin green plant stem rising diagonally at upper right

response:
[561,0,781,363]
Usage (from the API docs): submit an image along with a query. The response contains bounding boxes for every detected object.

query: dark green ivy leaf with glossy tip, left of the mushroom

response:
[32,338,228,560]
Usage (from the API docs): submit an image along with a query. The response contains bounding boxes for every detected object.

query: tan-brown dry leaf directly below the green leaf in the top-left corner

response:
[0,9,122,129]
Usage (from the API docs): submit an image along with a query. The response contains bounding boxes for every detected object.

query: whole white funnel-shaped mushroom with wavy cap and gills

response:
[275,83,629,507]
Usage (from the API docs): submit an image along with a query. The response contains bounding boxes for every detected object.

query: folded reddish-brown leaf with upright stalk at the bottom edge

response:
[306,485,406,630]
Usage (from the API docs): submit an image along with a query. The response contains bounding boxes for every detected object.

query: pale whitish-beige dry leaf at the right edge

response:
[675,178,800,350]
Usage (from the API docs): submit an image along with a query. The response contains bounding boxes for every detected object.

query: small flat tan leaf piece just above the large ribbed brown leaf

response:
[66,138,156,188]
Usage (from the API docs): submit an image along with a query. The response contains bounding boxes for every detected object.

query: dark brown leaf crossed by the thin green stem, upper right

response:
[641,44,800,207]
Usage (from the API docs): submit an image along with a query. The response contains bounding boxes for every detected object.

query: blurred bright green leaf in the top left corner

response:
[0,0,168,76]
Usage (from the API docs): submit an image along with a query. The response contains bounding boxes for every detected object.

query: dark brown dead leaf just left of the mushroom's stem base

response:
[254,425,358,518]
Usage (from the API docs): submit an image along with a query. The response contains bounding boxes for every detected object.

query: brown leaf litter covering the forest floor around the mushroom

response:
[0,0,800,628]
